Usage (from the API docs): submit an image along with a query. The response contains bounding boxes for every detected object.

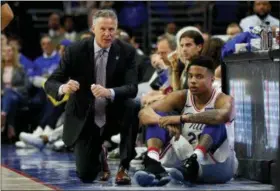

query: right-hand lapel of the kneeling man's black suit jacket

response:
[106,41,120,87]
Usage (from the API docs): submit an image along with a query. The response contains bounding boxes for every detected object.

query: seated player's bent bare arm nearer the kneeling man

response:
[139,90,186,125]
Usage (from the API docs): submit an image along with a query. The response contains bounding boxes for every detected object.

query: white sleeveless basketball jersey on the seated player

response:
[182,89,234,162]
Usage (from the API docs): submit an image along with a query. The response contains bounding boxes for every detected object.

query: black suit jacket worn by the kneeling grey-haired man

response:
[45,37,138,146]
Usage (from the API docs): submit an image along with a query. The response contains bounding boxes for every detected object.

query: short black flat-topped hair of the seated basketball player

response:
[187,56,215,74]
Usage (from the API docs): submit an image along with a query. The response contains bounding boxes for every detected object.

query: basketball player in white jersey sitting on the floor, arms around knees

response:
[134,56,237,186]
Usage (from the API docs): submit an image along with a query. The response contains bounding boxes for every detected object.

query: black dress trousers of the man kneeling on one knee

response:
[74,99,140,182]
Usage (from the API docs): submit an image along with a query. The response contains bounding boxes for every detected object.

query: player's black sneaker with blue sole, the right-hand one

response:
[169,154,199,185]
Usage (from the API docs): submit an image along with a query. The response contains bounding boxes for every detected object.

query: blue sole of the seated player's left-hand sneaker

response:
[134,170,171,187]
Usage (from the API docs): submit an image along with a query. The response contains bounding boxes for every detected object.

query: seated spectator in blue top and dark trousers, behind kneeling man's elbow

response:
[16,36,65,147]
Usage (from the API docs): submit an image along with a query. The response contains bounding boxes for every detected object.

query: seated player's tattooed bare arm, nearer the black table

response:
[182,93,234,125]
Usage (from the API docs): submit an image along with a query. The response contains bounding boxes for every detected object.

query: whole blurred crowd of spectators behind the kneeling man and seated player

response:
[1,2,279,160]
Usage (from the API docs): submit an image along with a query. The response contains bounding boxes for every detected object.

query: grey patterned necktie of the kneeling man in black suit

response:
[94,49,107,128]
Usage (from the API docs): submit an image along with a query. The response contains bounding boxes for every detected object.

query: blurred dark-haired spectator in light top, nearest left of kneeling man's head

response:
[62,15,78,42]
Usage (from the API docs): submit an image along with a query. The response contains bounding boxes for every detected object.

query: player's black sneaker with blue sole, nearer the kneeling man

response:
[134,155,171,186]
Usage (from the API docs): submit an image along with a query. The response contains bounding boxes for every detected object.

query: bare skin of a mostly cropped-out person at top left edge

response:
[1,1,14,31]
